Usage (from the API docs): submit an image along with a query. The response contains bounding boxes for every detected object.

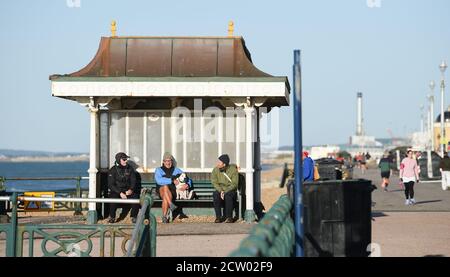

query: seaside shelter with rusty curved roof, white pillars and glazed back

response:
[50,28,290,223]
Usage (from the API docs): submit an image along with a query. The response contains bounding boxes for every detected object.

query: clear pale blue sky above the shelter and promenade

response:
[0,0,450,152]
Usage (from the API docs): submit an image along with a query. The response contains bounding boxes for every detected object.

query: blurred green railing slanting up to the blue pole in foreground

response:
[230,195,295,257]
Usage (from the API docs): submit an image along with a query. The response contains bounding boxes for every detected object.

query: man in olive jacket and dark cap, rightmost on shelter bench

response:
[211,154,239,223]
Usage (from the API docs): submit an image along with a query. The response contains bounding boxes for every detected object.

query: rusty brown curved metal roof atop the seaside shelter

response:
[50,37,271,80]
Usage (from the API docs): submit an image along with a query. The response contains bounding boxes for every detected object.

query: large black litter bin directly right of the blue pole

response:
[303,179,375,257]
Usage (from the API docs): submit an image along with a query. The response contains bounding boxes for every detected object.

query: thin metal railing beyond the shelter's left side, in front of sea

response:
[0,176,89,215]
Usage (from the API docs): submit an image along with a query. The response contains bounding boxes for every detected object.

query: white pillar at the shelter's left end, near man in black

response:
[88,97,98,224]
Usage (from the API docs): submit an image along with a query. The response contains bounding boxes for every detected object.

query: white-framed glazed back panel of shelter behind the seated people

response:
[100,109,247,173]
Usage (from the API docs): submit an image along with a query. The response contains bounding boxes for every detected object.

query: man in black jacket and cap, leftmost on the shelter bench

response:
[108,152,140,223]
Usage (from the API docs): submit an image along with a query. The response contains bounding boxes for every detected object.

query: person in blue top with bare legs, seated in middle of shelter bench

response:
[155,152,192,223]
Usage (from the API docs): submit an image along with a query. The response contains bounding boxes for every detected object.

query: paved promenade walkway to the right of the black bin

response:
[355,165,450,257]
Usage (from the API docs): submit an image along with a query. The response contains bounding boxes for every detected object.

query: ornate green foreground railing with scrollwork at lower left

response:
[0,191,156,257]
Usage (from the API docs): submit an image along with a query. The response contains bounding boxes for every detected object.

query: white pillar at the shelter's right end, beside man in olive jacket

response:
[244,100,256,223]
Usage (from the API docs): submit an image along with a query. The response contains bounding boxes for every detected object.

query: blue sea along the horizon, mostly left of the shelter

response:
[0,161,274,192]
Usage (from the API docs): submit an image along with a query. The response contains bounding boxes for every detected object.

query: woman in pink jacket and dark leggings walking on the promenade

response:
[400,150,419,205]
